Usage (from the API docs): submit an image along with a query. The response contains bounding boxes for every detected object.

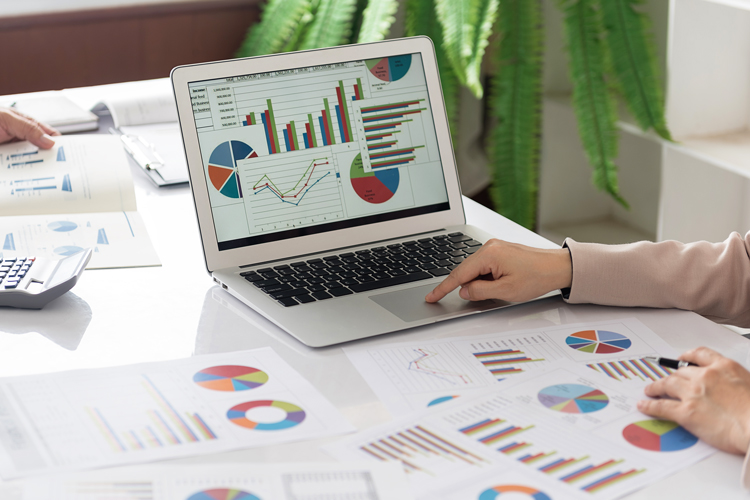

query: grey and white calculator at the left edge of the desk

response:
[0,248,93,309]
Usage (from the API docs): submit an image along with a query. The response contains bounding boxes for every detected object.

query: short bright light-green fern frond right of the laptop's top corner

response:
[435,0,499,98]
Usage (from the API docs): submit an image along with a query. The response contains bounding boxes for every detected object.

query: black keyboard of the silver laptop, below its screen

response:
[240,233,482,307]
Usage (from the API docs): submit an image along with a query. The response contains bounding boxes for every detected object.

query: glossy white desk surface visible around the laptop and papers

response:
[0,81,750,499]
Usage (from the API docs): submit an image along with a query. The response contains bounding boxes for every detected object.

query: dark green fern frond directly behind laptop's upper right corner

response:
[406,0,460,139]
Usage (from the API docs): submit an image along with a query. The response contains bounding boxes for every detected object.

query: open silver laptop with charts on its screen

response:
[171,37,552,347]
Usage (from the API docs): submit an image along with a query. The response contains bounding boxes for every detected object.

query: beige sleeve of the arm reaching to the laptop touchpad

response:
[565,232,750,327]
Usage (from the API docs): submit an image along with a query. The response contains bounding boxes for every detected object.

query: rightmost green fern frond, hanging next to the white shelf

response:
[599,0,672,141]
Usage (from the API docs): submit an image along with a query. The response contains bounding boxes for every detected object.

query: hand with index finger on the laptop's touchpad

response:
[425,240,573,302]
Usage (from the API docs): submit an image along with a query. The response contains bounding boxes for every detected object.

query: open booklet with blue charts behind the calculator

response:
[0,135,160,269]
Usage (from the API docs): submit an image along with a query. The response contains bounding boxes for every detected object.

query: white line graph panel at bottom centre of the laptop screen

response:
[240,148,344,232]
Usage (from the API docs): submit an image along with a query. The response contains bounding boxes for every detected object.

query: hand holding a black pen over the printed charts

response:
[638,347,750,455]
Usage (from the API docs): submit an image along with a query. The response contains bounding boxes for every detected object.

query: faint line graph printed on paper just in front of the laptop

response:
[371,344,486,394]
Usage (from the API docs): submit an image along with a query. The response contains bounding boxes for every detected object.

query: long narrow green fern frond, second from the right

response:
[559,0,628,207]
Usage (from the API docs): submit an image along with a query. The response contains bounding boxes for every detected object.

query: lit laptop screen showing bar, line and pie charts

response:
[189,53,450,250]
